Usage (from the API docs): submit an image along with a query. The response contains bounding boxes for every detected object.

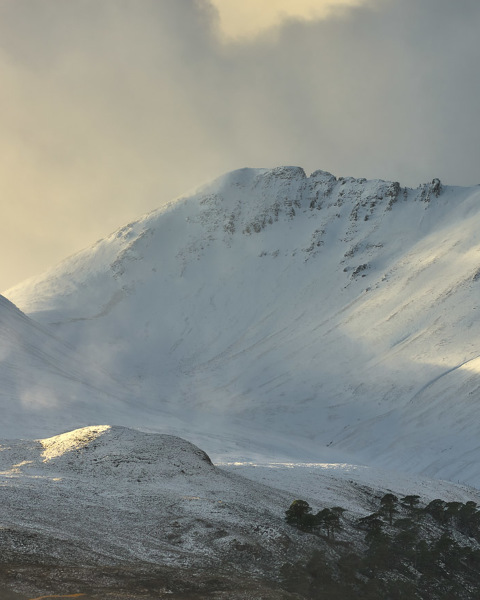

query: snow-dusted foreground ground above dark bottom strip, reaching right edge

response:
[0,425,480,576]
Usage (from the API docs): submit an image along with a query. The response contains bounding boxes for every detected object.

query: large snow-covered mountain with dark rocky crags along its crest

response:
[5,167,480,484]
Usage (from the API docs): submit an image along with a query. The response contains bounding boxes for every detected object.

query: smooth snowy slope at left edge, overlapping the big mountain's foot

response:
[0,296,135,437]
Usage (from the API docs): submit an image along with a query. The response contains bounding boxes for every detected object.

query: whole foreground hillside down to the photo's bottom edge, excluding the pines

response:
[0,425,480,600]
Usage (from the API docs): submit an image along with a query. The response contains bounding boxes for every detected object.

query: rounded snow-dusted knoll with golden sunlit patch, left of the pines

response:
[0,426,306,572]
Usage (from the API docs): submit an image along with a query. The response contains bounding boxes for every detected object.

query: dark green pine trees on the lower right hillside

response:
[281,494,480,600]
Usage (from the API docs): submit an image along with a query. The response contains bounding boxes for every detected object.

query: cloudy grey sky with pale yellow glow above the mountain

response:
[0,0,480,290]
